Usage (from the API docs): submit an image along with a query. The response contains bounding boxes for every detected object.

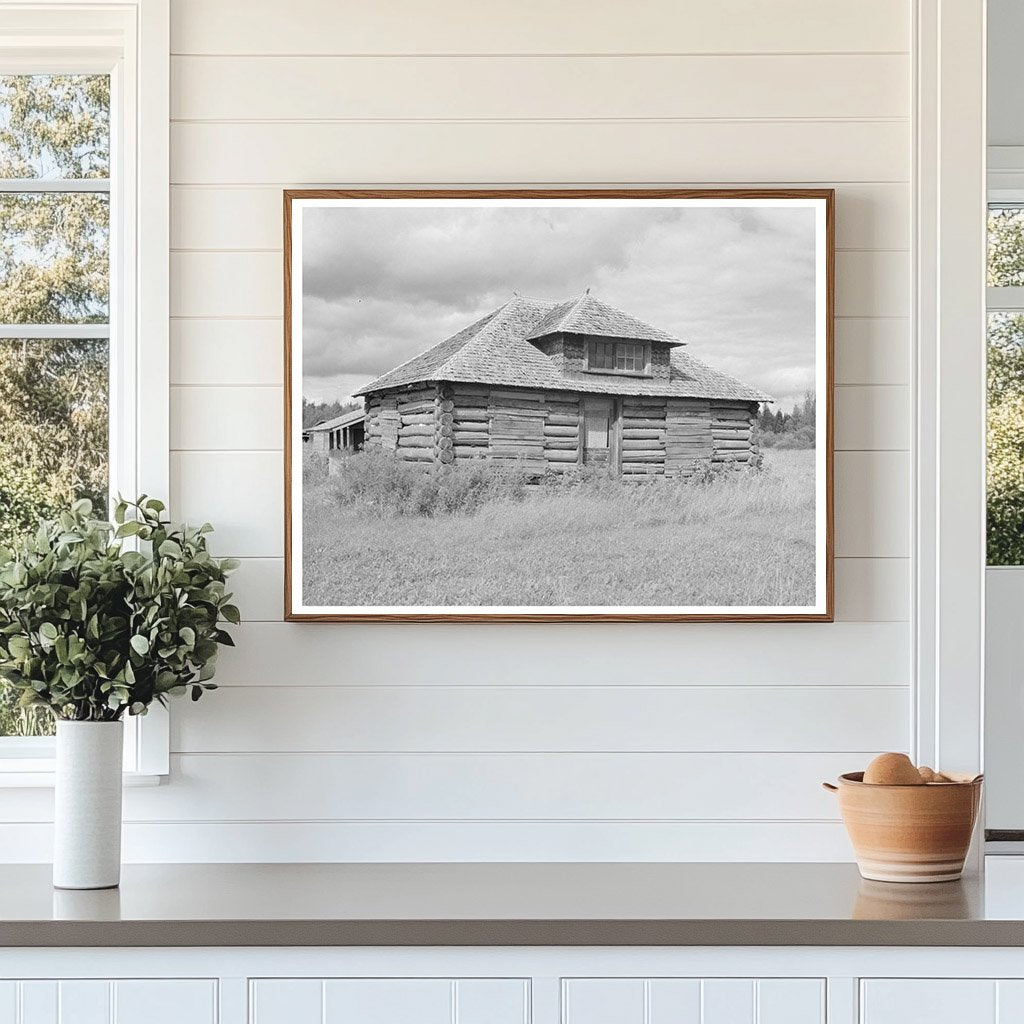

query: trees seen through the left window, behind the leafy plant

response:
[0,75,111,736]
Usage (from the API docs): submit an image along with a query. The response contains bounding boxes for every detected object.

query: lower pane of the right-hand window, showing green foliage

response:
[987,313,1024,565]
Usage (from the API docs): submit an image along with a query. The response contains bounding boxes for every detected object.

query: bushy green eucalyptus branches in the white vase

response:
[0,495,240,722]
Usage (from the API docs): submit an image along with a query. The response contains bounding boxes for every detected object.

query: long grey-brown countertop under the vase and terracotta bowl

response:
[6,858,1024,946]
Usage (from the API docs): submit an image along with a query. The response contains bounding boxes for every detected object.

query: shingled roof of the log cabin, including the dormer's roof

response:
[355,294,771,401]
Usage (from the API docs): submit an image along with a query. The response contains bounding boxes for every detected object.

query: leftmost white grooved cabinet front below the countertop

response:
[0,978,217,1024]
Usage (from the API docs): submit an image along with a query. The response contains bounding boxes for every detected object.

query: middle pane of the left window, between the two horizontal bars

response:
[0,193,110,324]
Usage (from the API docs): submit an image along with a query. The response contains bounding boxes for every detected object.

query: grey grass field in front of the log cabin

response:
[303,451,814,607]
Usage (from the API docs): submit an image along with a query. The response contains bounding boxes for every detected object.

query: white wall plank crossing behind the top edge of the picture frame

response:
[171,181,910,251]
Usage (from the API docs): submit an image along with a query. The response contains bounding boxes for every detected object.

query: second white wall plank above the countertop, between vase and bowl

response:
[114,751,856,821]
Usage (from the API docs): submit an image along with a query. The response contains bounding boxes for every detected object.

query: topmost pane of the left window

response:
[0,75,111,180]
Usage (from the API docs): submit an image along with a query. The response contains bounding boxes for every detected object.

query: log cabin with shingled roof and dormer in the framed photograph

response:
[356,289,771,479]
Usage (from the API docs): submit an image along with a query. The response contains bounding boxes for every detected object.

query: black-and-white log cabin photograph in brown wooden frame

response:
[285,188,835,622]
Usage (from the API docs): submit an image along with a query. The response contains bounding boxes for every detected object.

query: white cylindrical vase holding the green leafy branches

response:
[53,721,124,889]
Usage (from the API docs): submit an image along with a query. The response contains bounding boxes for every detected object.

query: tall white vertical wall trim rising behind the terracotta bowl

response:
[913,0,987,771]
